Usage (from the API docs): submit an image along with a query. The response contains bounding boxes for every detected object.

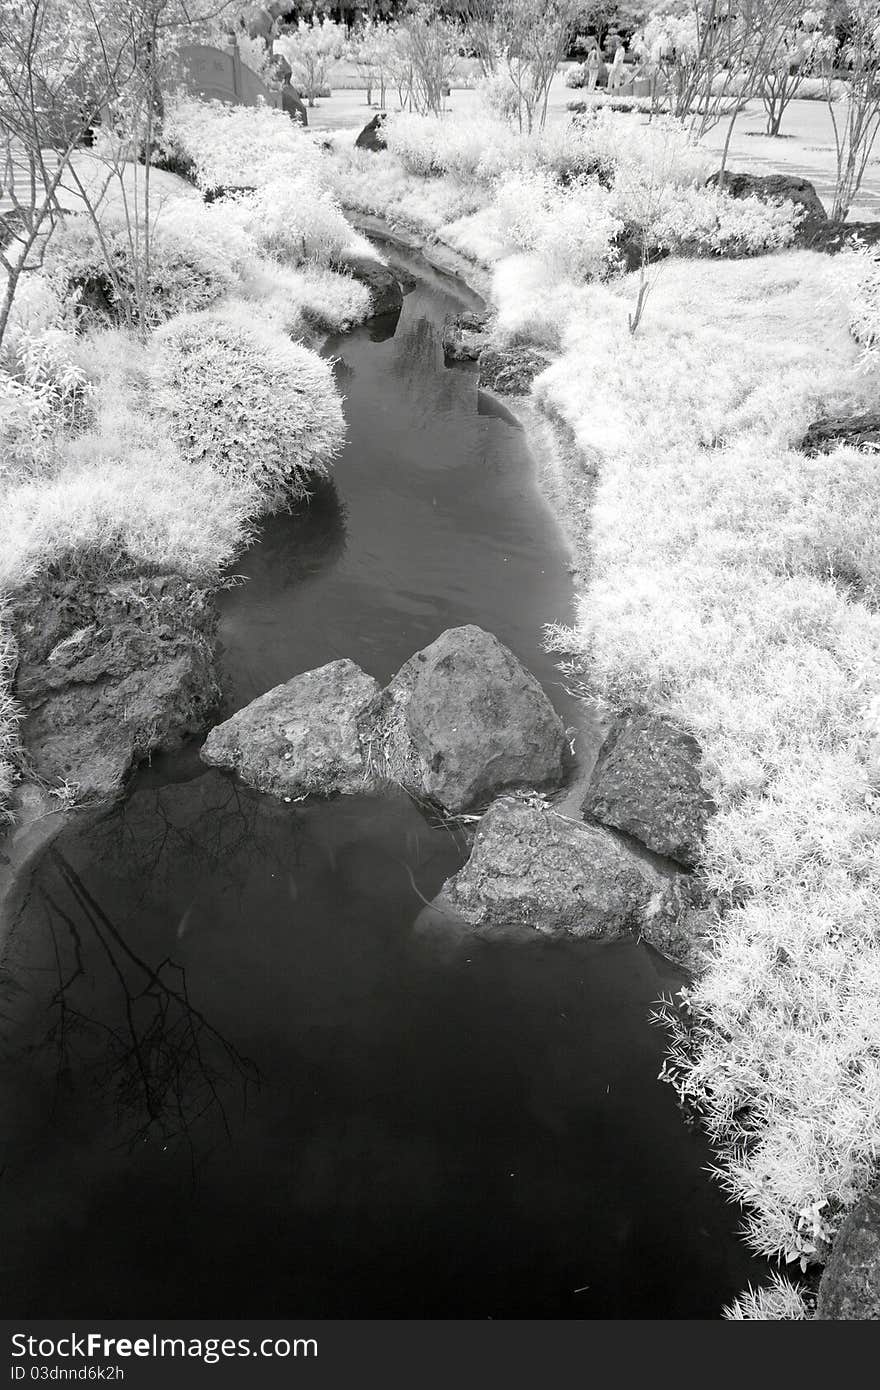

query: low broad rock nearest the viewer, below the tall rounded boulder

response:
[431,796,685,952]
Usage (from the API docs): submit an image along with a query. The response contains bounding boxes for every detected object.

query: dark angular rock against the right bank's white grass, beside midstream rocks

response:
[582,714,715,869]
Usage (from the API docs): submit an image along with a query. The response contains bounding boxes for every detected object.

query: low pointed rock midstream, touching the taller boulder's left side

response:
[200,660,380,796]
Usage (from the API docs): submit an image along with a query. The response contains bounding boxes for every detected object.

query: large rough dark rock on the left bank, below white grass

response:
[10,574,220,799]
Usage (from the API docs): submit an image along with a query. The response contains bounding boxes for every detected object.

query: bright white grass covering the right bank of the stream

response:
[326,118,880,1289]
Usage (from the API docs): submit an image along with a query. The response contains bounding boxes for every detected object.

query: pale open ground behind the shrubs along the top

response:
[309,68,880,221]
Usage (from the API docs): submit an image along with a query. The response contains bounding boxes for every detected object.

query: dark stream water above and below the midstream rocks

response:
[0,247,753,1318]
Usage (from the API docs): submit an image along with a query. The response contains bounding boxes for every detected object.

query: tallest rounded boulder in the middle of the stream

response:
[361,624,564,812]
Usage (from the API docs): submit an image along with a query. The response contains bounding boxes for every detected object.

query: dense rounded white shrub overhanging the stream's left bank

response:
[156,313,345,512]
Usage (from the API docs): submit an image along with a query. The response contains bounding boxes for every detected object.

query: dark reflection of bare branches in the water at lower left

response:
[27,849,259,1172]
